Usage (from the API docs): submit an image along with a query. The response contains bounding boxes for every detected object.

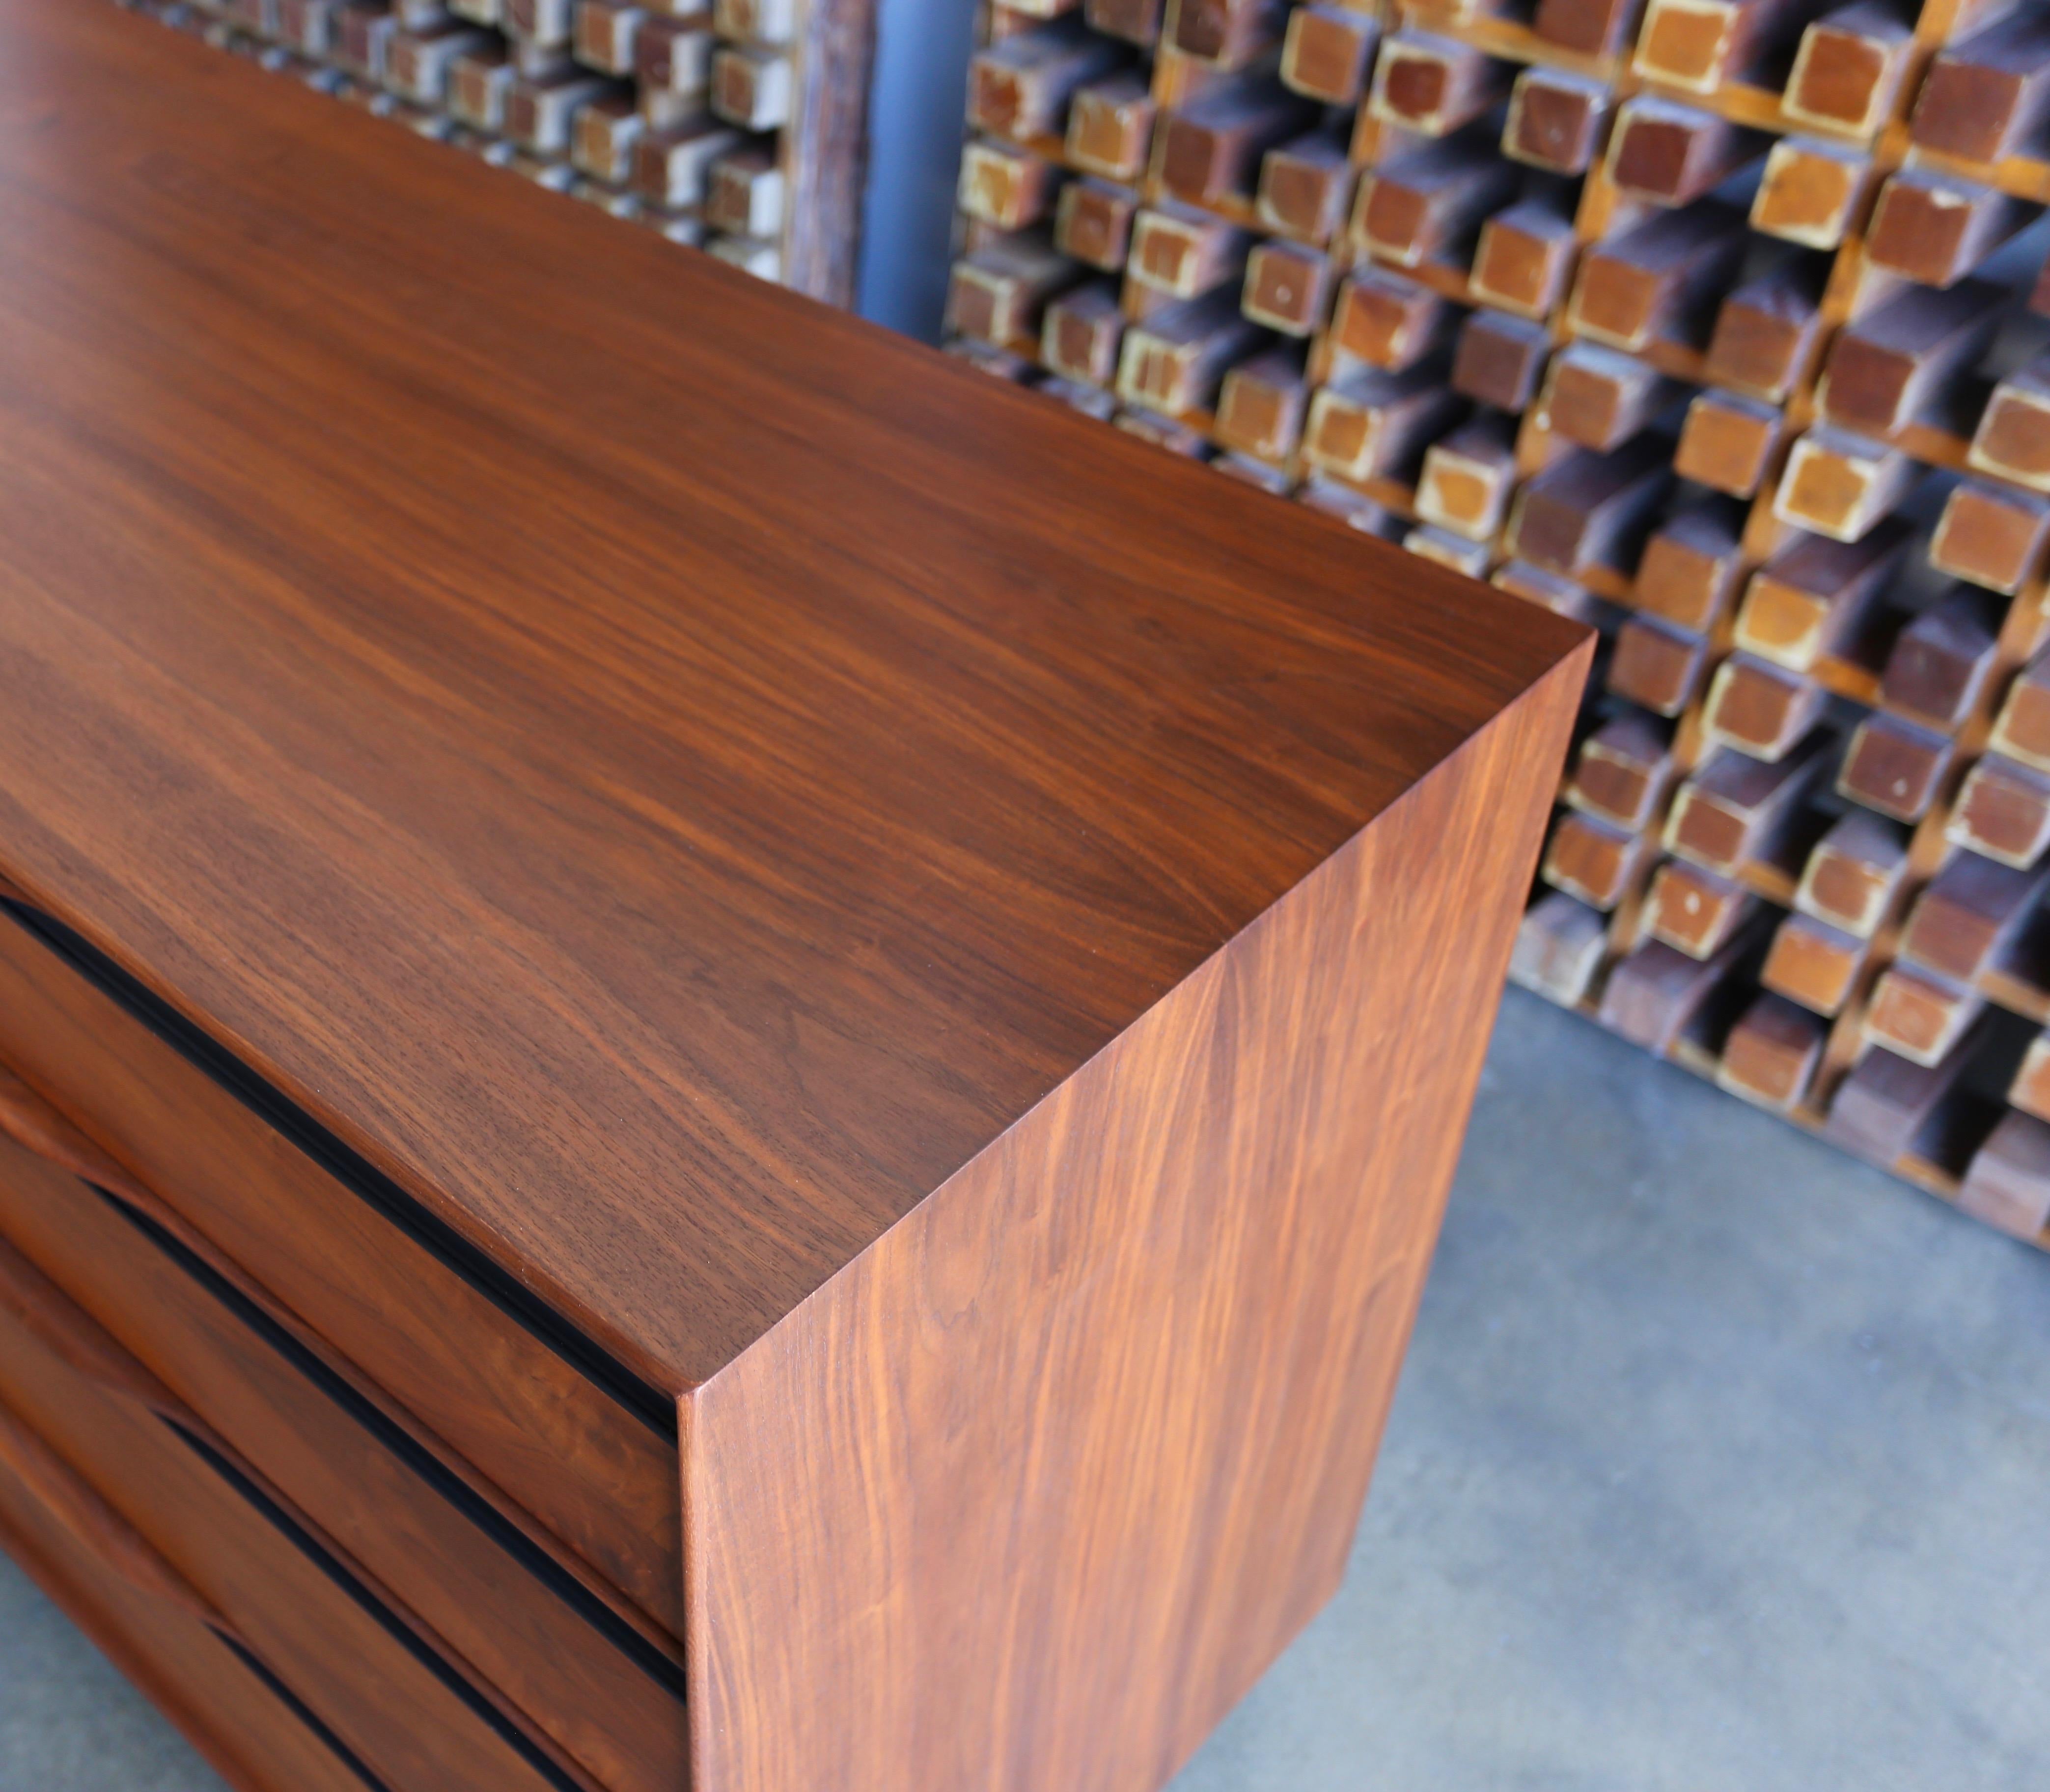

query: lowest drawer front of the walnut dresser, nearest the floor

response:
[0,1413,377,1792]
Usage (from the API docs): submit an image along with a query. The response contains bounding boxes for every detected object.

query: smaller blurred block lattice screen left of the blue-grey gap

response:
[123,0,875,306]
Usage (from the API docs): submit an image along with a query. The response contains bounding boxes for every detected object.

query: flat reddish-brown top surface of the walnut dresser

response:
[0,0,1582,1386]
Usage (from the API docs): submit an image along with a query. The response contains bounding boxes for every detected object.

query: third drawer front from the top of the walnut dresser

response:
[0,1247,594,1792]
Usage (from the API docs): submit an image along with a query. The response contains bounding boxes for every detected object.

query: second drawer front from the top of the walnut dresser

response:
[0,1138,689,1792]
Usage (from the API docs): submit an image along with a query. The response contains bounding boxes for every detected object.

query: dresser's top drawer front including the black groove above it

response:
[0,902,683,1636]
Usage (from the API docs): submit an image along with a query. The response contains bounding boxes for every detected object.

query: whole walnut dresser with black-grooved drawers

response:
[0,0,1589,1792]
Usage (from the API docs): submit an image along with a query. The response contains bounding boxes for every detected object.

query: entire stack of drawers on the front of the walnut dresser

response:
[0,902,689,1792]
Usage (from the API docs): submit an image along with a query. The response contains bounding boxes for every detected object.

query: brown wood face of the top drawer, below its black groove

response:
[0,915,683,1636]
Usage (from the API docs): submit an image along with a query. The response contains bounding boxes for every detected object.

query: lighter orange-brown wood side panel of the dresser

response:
[683,660,1582,1792]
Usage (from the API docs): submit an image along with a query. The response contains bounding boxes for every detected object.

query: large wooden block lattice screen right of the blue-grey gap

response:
[949,0,2050,1242]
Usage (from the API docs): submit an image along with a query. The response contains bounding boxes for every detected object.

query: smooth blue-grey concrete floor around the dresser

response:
[0,990,2050,1792]
